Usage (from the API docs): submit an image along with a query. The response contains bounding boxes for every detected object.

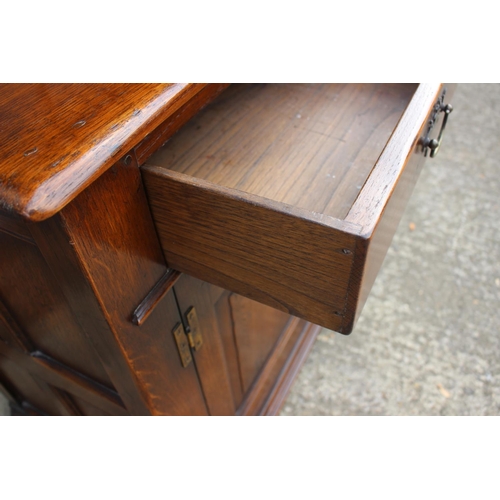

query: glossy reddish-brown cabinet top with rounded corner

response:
[0,83,204,221]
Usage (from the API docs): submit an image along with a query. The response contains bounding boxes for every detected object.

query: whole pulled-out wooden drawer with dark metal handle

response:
[142,84,453,334]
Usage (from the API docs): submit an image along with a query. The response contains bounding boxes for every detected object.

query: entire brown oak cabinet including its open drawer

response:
[0,84,453,416]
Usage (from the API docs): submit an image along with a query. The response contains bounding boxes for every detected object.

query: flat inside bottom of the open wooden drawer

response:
[148,84,416,219]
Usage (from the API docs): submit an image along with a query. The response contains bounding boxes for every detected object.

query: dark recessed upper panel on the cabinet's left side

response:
[0,232,113,389]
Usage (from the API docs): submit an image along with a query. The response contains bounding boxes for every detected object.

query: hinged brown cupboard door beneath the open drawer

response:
[174,275,291,415]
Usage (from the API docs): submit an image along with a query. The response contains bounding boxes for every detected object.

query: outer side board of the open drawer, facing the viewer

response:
[143,166,358,330]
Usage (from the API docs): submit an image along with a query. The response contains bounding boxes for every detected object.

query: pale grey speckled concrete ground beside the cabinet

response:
[0,84,500,415]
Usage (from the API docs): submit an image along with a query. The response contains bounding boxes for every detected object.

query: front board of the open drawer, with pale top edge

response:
[342,83,456,332]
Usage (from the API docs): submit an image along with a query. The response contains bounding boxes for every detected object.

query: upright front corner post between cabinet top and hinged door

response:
[54,159,207,415]
